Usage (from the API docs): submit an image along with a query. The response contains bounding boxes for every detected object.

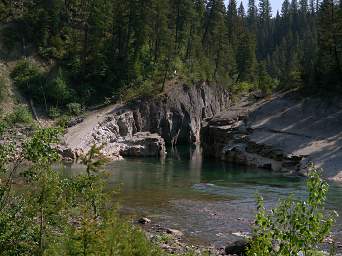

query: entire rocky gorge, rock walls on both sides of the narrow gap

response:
[60,83,342,180]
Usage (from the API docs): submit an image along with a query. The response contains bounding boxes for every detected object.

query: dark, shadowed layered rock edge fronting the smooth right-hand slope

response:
[201,110,304,173]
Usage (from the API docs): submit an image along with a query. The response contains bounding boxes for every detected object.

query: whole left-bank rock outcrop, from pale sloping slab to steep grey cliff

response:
[60,83,229,159]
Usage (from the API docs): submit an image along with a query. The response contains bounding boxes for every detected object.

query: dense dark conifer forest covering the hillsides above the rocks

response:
[0,0,342,105]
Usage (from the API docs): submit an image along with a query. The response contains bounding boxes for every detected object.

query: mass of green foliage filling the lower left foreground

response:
[0,128,166,256]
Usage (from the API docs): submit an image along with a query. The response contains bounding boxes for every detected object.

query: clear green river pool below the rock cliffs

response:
[63,148,342,246]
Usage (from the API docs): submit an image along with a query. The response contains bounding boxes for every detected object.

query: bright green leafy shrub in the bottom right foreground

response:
[247,166,334,256]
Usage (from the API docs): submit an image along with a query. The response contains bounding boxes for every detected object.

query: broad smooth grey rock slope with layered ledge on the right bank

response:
[201,92,342,181]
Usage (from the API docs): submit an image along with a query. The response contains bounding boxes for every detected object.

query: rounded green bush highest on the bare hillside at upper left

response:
[11,60,45,100]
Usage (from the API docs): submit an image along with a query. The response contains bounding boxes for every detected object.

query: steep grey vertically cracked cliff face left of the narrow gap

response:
[132,83,229,145]
